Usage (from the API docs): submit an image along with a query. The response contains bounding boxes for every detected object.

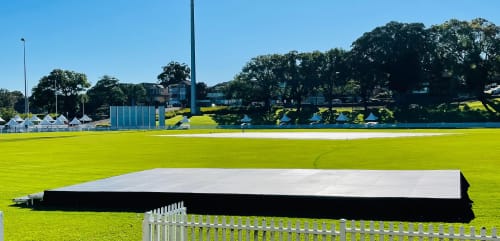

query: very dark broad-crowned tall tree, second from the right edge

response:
[351,22,428,108]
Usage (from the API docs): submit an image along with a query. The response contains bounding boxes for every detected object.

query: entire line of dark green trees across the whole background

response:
[0,18,500,120]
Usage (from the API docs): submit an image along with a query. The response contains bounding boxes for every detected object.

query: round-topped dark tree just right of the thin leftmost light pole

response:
[32,69,90,114]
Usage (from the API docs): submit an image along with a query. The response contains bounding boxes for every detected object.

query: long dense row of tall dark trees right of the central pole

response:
[224,19,500,112]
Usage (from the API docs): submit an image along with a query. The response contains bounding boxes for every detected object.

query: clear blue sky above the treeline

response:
[0,0,500,94]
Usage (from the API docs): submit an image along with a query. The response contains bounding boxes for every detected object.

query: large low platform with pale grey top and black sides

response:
[41,168,474,222]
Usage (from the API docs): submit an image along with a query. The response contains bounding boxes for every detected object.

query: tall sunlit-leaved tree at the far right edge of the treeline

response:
[431,18,500,112]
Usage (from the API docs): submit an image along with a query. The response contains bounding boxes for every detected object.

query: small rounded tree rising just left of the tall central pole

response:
[158,61,191,87]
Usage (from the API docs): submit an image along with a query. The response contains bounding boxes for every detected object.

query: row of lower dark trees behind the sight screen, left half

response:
[0,62,207,118]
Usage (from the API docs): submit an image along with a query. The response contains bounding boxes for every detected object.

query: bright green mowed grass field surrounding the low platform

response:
[0,129,500,241]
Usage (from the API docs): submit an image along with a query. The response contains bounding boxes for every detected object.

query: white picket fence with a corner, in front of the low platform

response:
[142,203,500,241]
